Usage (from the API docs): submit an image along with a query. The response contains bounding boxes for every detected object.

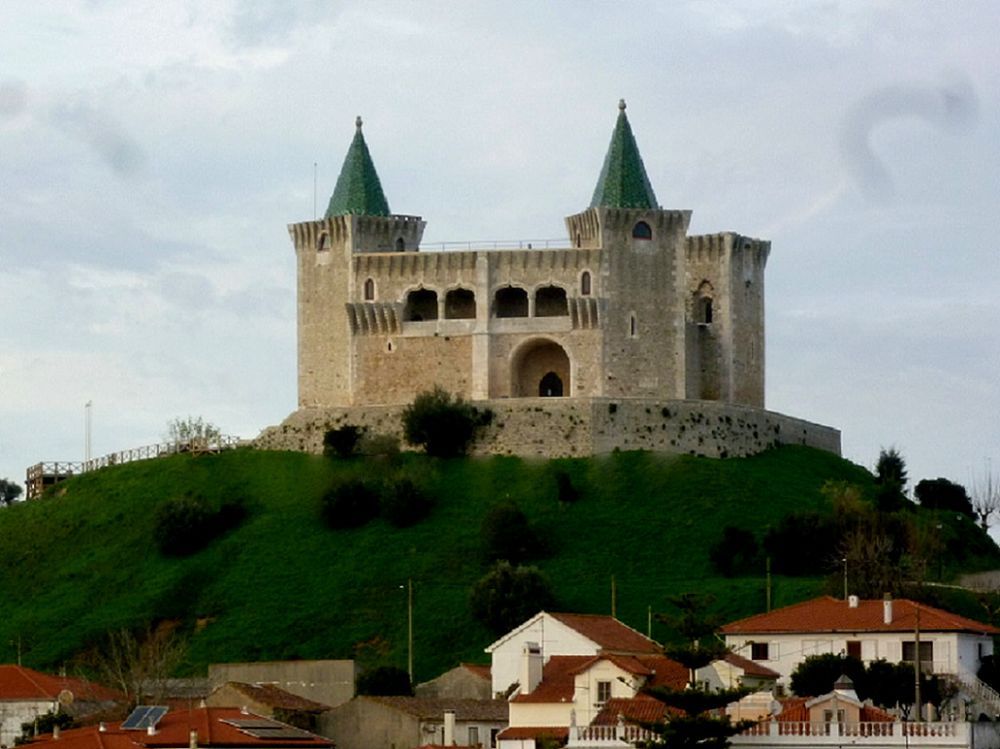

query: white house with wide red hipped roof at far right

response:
[721,596,1000,685]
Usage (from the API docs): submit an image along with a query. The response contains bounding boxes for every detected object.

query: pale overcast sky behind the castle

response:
[0,0,1000,502]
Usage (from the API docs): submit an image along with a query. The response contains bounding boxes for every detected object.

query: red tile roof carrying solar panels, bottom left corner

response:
[32,707,333,749]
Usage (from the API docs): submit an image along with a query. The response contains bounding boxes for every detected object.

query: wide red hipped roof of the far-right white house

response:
[721,596,1000,635]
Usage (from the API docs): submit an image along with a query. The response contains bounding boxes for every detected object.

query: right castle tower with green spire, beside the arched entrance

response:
[566,101,691,398]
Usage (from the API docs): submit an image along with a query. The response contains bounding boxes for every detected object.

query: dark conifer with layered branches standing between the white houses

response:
[643,593,753,749]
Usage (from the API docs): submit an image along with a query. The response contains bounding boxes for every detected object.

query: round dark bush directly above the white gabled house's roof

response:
[469,561,555,635]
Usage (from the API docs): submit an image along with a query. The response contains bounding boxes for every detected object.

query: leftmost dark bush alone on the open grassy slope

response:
[154,494,246,557]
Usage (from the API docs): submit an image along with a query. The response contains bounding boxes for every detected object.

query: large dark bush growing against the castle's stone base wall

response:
[403,386,493,458]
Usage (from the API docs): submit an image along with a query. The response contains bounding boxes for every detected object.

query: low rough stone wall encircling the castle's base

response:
[255,398,840,458]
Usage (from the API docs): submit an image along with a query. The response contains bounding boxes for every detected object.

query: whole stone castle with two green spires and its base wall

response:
[259,102,840,456]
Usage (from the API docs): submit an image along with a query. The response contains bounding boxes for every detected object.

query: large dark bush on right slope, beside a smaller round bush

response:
[764,511,840,575]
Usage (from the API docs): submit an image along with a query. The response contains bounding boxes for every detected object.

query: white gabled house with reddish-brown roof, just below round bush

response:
[486,611,660,695]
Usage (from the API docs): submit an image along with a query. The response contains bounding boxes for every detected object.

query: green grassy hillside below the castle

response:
[0,447,997,680]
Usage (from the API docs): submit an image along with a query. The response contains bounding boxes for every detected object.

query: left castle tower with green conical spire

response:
[288,117,426,407]
